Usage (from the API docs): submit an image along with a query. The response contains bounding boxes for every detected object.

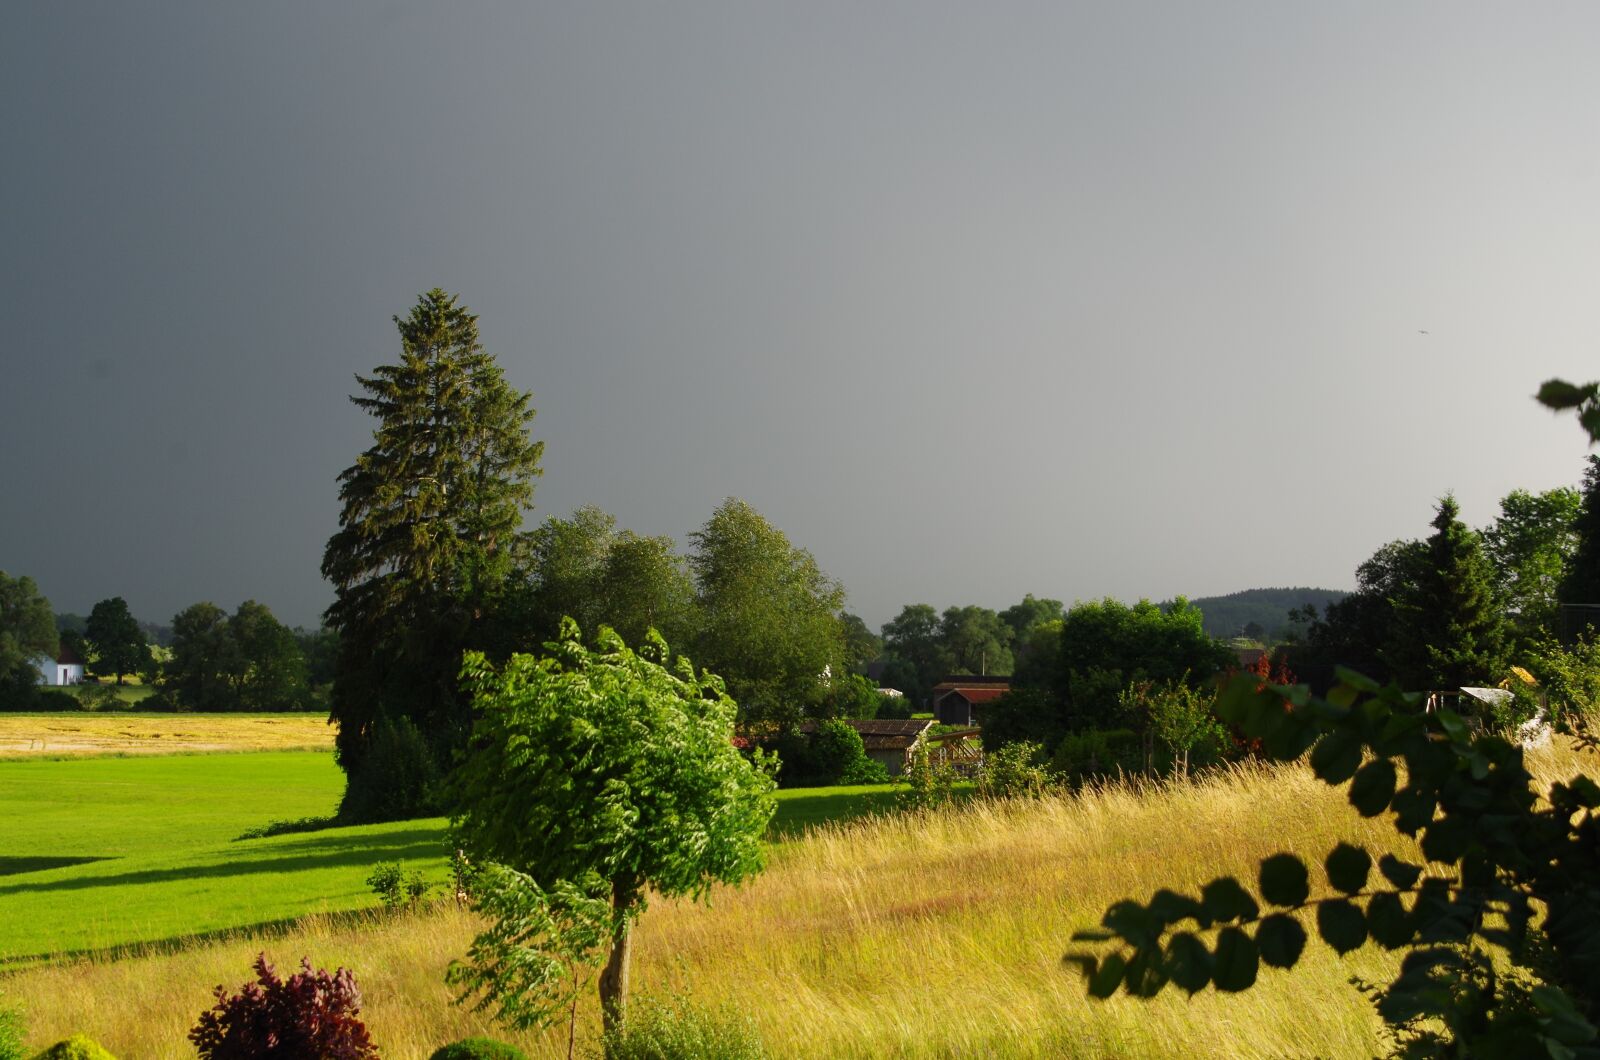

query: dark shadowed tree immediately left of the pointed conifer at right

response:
[1290,540,1427,692]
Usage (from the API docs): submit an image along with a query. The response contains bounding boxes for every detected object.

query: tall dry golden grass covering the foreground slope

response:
[12,748,1600,1057]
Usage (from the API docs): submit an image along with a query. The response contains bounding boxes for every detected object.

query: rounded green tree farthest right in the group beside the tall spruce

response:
[690,498,845,724]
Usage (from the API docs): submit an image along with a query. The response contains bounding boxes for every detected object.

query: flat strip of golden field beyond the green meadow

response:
[0,713,334,759]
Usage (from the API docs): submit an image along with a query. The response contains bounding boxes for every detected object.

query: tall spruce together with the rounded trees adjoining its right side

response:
[322,288,861,818]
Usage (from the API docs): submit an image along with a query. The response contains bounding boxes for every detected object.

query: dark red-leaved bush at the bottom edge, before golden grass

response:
[189,953,378,1060]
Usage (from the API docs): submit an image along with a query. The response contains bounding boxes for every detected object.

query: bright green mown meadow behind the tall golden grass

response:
[0,751,896,964]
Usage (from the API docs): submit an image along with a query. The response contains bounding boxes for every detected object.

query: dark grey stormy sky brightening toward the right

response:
[0,0,1600,628]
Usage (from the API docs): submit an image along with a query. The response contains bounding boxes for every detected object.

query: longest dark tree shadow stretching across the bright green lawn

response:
[0,828,445,897]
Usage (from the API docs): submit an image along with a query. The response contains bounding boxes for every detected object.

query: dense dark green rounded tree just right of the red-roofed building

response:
[1056,597,1234,729]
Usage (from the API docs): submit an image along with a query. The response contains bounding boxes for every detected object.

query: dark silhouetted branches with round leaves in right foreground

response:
[1066,669,1600,1060]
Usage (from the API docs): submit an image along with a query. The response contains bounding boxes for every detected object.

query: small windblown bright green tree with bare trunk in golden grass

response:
[450,623,776,1031]
